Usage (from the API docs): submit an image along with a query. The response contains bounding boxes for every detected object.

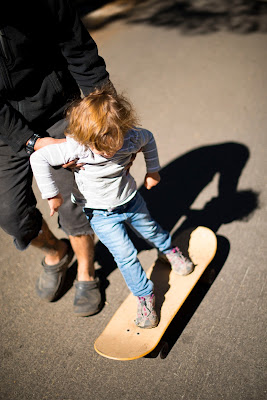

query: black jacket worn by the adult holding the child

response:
[0,0,108,152]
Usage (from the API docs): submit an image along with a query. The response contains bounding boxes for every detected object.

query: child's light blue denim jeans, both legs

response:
[84,192,171,296]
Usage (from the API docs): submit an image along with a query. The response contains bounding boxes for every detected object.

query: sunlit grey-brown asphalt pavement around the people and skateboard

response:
[0,3,267,400]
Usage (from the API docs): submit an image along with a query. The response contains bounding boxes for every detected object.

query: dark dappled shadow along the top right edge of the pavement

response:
[127,0,267,34]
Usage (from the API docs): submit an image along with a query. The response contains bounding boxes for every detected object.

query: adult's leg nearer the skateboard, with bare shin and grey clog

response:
[45,120,101,316]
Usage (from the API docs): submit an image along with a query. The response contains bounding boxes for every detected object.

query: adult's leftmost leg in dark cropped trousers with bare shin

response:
[0,143,74,299]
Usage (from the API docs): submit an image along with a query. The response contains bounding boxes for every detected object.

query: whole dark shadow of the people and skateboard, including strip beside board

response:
[92,142,258,357]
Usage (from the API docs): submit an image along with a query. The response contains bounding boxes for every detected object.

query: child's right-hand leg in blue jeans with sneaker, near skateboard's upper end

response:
[127,193,194,275]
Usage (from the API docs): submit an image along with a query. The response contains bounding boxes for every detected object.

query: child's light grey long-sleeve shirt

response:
[30,128,160,209]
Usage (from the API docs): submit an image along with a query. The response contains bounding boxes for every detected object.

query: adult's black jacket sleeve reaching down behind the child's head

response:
[54,0,109,96]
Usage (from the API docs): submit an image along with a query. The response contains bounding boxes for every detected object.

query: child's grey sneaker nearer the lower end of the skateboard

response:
[134,293,159,329]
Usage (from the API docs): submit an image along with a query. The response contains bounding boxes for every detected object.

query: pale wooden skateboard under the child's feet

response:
[94,226,217,361]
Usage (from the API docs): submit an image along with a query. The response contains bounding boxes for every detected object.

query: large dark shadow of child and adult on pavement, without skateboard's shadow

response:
[95,142,258,279]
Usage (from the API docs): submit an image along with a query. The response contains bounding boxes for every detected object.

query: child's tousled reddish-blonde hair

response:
[65,84,138,153]
